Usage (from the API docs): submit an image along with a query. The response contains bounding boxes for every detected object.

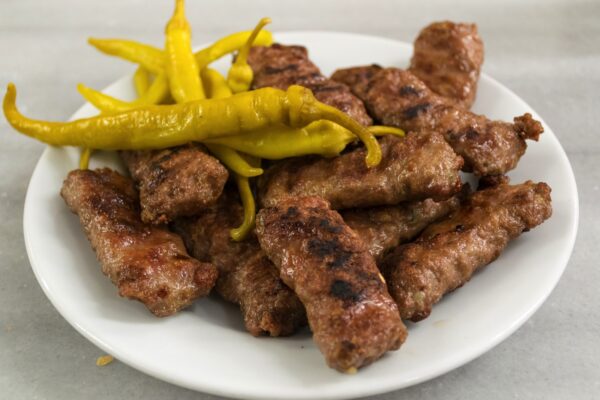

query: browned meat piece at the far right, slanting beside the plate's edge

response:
[381,181,552,321]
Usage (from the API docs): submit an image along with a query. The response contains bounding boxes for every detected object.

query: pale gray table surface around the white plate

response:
[0,0,600,400]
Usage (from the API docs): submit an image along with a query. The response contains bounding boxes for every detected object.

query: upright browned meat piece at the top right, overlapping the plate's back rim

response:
[410,21,483,110]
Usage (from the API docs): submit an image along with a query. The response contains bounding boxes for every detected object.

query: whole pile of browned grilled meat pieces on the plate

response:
[61,22,551,372]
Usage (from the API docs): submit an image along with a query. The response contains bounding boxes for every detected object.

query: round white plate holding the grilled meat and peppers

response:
[24,32,578,399]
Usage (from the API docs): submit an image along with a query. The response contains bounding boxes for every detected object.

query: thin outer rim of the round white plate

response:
[23,30,580,400]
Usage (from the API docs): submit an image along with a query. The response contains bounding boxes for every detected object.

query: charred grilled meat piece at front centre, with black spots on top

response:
[256,197,406,372]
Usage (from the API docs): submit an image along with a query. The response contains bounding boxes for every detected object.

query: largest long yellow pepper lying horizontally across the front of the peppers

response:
[3,83,381,167]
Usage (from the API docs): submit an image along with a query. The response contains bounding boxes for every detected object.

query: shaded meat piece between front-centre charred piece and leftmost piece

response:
[173,191,306,336]
